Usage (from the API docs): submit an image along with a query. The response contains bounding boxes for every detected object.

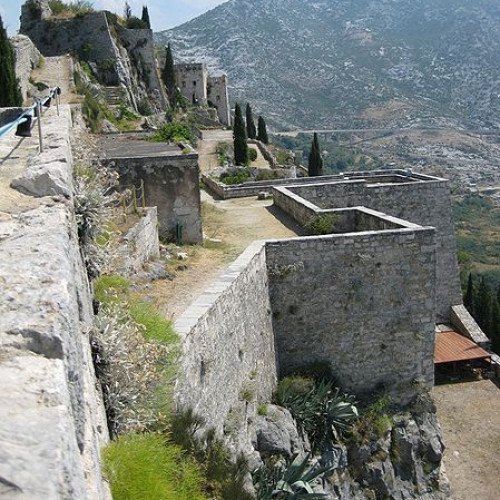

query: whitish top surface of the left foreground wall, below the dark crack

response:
[0,350,89,499]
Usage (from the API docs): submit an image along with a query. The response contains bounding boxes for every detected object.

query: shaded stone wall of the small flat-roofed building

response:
[106,151,203,243]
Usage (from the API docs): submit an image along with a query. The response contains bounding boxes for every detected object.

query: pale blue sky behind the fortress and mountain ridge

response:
[0,0,227,35]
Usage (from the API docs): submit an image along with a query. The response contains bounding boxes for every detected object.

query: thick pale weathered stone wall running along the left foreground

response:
[0,106,110,499]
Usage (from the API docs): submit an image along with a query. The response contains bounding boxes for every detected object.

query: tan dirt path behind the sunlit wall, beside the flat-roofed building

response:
[148,192,299,319]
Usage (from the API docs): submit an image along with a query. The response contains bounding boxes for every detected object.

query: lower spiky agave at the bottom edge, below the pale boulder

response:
[254,453,331,500]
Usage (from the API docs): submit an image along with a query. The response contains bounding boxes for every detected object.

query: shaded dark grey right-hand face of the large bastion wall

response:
[266,228,436,399]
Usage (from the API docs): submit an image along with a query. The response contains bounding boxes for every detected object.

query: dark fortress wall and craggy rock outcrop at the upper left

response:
[20,0,167,111]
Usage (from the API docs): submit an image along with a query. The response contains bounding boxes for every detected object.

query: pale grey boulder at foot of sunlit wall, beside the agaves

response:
[255,405,304,457]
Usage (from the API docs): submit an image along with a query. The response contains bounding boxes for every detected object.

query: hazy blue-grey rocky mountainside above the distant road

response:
[156,0,500,128]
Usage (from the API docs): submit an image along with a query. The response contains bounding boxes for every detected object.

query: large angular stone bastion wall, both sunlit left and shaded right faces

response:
[175,205,436,432]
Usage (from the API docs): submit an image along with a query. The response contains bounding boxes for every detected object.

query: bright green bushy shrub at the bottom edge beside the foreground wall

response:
[103,433,207,500]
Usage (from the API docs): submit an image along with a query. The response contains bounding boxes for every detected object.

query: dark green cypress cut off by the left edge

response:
[0,17,23,108]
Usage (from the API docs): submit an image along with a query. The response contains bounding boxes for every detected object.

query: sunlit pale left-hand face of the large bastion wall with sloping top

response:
[174,242,276,433]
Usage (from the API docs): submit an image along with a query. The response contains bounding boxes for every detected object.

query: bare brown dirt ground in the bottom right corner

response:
[433,380,500,500]
